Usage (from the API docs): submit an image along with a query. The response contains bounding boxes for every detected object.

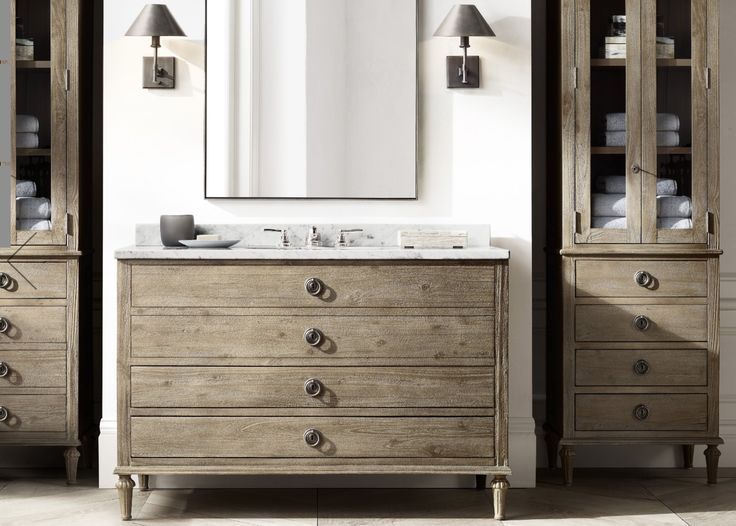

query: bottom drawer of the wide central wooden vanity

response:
[131,417,494,458]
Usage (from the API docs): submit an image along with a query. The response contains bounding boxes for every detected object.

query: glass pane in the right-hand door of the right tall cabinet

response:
[657,0,693,230]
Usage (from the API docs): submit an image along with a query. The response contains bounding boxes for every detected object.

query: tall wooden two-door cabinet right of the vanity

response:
[547,0,722,484]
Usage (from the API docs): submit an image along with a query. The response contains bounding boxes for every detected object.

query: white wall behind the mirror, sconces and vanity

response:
[100,0,535,487]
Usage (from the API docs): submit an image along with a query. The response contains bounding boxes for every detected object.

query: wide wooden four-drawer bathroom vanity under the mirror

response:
[116,247,511,519]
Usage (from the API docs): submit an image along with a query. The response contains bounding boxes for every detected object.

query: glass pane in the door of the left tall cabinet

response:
[15,0,52,231]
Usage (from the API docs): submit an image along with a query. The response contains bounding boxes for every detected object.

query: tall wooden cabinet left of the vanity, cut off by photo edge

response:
[0,0,81,482]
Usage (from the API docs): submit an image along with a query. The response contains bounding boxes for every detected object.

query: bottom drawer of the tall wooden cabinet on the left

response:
[0,394,66,434]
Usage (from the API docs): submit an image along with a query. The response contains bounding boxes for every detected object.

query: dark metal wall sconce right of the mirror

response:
[434,4,496,88]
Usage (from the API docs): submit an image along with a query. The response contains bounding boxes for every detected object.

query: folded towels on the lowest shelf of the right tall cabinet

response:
[591,175,693,230]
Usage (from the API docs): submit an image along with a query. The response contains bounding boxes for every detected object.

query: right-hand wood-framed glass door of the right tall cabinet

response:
[641,0,708,243]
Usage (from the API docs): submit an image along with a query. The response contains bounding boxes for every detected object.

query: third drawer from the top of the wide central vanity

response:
[131,367,494,408]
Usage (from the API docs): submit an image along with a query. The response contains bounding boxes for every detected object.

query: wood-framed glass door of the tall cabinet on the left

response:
[11,0,66,245]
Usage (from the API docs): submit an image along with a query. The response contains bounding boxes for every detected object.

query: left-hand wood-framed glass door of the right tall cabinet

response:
[575,0,641,243]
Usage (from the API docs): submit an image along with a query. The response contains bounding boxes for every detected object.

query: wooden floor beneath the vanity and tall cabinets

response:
[0,470,736,526]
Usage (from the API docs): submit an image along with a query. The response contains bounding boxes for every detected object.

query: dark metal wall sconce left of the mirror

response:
[125,4,187,89]
